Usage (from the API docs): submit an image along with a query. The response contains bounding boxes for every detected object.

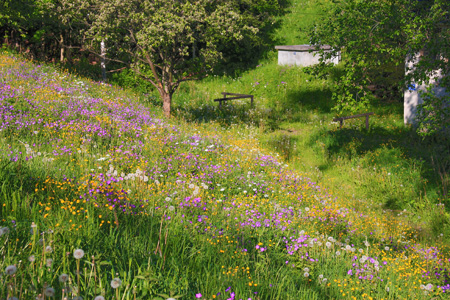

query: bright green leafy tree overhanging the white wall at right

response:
[311,0,450,129]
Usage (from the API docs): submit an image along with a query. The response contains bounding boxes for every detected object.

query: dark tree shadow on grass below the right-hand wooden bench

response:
[310,125,450,209]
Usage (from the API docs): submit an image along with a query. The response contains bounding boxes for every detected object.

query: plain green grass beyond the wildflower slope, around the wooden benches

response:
[163,1,450,220]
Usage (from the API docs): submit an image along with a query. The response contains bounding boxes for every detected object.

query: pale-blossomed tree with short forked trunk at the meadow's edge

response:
[79,0,258,117]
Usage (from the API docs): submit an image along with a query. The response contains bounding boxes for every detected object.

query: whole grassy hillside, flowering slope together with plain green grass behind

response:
[0,0,450,300]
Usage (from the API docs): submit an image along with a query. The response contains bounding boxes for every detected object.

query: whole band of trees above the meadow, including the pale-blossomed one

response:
[0,0,281,116]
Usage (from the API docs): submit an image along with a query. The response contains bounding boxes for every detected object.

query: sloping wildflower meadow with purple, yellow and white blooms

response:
[0,53,450,300]
